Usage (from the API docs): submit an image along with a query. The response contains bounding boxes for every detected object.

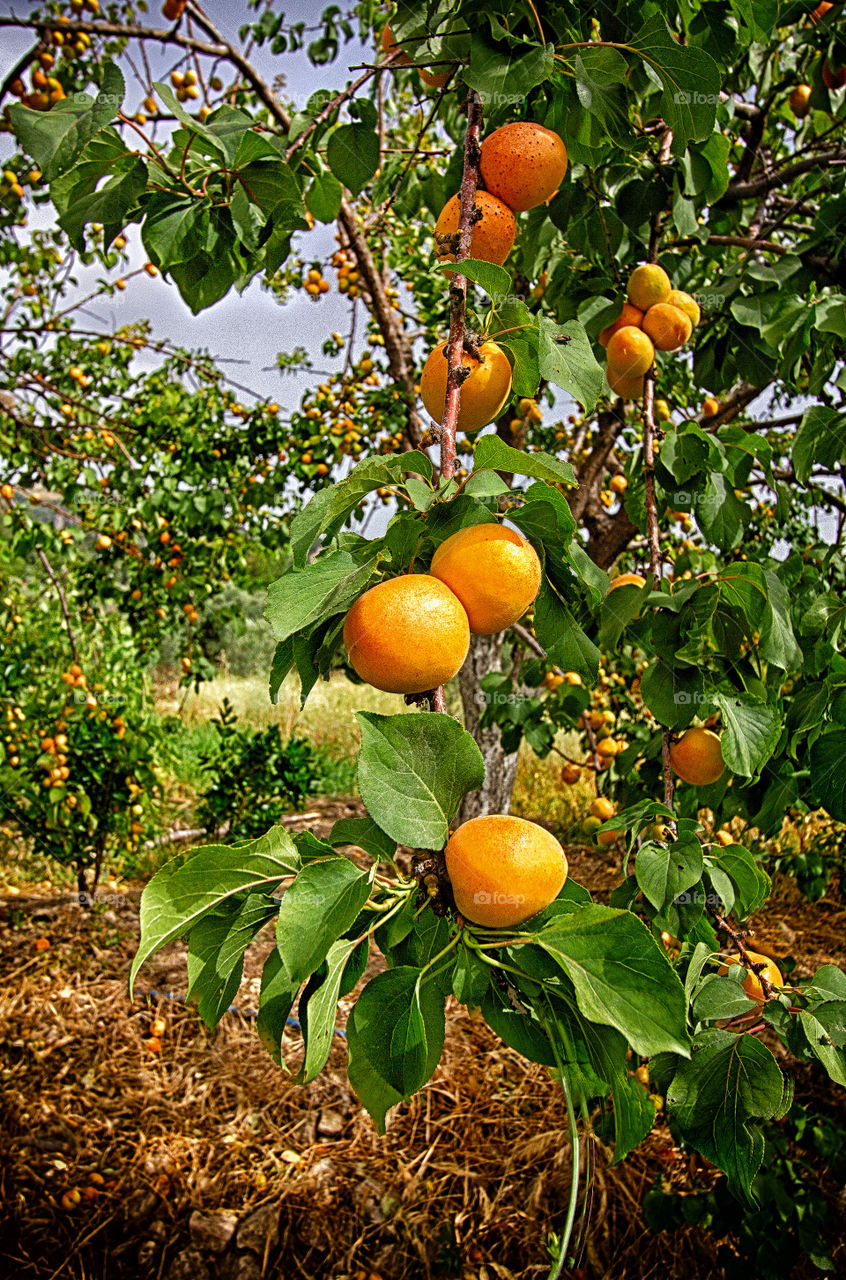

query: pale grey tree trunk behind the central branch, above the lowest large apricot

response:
[457,635,517,822]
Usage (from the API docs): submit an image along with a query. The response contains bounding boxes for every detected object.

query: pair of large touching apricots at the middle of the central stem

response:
[344,524,540,694]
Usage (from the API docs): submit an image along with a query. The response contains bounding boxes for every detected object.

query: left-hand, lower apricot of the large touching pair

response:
[344,573,470,694]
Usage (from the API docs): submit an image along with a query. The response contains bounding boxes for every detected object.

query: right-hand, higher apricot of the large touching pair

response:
[430,525,540,636]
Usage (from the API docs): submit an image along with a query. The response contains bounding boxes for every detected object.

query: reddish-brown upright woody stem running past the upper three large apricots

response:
[431,90,481,712]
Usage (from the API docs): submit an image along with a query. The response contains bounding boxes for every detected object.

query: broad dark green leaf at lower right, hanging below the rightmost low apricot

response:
[667,1028,785,1203]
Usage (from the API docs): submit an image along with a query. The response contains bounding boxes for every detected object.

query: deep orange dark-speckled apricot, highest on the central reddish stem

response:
[479,120,567,212]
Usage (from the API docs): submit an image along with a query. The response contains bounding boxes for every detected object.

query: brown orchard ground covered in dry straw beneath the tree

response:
[0,801,846,1280]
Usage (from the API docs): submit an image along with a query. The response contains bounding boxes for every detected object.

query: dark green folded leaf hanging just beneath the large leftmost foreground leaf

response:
[187,893,279,1029]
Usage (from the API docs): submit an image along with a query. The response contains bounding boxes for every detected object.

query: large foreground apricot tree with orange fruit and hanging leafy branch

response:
[0,0,846,1271]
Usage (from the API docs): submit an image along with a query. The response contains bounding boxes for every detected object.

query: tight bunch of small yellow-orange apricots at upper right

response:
[599,270,700,399]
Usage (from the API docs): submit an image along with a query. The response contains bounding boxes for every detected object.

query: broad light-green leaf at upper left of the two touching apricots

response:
[265,552,378,640]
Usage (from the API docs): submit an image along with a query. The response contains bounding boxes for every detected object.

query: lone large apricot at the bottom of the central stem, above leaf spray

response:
[444,814,567,929]
